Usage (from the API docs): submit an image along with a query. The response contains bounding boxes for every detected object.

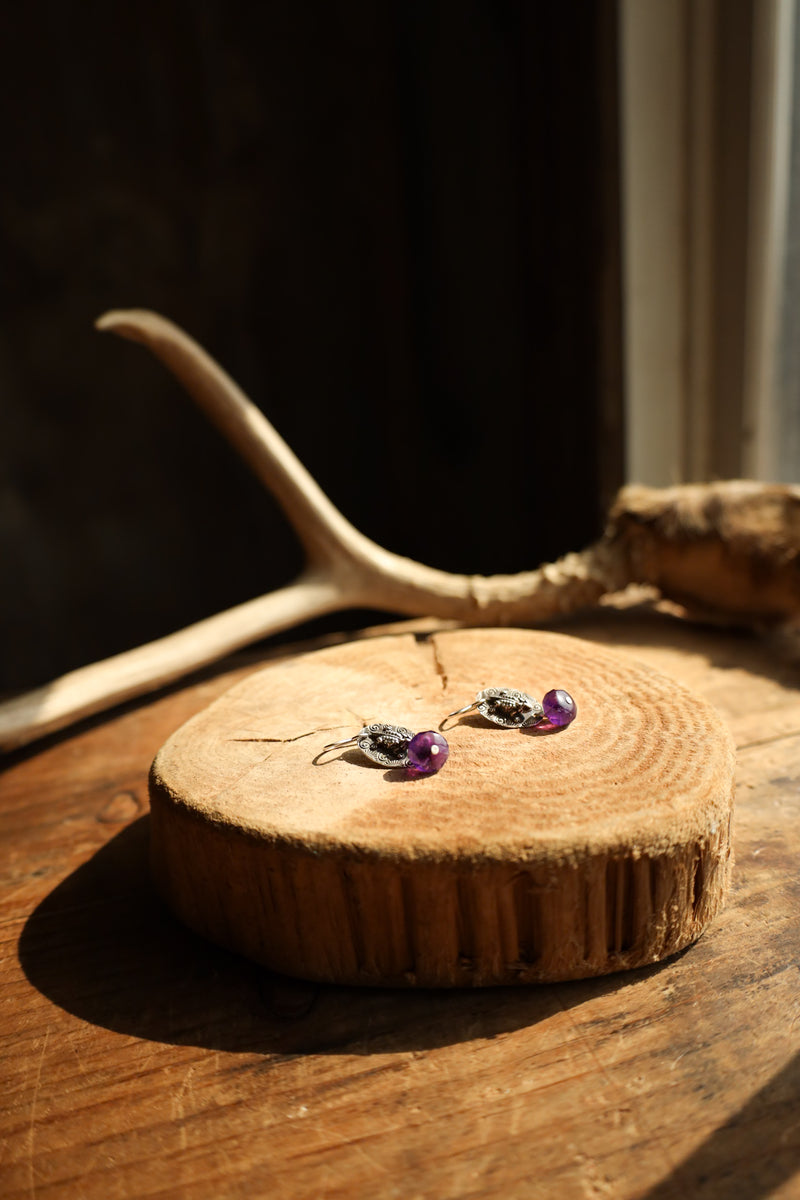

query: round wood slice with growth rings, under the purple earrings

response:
[150,629,734,988]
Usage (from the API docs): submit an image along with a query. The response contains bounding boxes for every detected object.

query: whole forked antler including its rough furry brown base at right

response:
[0,310,800,750]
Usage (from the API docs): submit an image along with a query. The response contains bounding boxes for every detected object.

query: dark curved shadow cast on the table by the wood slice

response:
[19,817,658,1055]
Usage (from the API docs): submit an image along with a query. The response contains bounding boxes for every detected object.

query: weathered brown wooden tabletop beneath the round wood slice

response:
[0,611,800,1200]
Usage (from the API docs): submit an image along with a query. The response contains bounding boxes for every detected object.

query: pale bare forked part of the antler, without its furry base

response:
[0,310,627,751]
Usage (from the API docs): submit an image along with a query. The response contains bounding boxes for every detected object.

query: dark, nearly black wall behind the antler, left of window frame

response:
[0,0,622,690]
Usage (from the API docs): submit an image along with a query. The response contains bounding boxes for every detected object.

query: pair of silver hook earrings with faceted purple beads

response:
[321,688,578,775]
